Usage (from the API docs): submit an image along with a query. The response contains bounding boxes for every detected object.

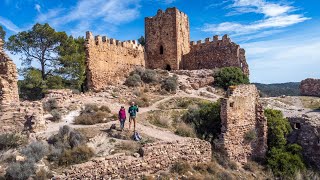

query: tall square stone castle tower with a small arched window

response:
[145,8,190,70]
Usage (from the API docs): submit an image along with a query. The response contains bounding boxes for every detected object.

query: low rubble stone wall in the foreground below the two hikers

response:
[63,139,212,179]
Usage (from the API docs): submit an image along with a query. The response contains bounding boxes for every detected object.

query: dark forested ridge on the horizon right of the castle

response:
[252,82,300,97]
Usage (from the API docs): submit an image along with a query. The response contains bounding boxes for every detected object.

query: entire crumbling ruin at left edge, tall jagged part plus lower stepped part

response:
[0,39,45,133]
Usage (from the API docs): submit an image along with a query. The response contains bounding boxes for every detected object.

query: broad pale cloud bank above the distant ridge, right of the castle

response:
[241,33,320,83]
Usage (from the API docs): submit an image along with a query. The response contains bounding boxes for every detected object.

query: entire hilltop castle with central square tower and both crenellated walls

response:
[85,8,249,90]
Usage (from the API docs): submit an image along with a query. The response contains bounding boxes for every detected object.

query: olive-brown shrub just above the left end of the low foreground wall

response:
[59,145,94,166]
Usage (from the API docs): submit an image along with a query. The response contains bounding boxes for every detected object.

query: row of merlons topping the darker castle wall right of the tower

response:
[190,34,233,47]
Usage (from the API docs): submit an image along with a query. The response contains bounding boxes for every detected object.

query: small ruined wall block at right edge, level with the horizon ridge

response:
[300,78,320,97]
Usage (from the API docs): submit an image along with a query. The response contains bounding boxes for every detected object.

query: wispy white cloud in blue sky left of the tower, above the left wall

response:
[36,0,140,35]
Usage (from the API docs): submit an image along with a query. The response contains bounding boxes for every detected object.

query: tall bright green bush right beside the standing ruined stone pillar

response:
[265,109,305,178]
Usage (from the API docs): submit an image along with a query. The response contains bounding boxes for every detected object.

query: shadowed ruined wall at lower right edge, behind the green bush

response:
[288,116,320,170]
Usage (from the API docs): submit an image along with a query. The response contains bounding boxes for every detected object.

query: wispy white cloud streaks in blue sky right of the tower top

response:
[202,0,311,36]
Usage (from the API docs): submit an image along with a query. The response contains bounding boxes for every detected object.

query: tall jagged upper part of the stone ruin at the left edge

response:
[0,39,19,106]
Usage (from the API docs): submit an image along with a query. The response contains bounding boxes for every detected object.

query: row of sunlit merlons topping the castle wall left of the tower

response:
[86,31,144,51]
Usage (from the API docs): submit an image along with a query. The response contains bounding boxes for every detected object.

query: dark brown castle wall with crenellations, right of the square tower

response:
[182,35,249,76]
